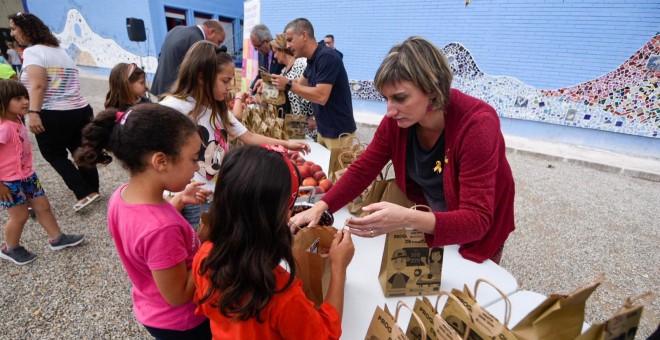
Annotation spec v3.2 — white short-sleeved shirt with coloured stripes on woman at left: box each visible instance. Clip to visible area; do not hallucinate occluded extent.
[21,45,88,111]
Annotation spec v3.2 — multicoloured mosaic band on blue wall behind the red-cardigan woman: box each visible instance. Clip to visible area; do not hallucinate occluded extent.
[351,33,660,138]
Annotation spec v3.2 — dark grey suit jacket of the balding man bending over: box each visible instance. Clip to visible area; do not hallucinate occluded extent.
[151,26,204,96]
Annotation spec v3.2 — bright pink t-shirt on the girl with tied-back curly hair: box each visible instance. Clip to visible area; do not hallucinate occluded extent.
[108,184,206,330]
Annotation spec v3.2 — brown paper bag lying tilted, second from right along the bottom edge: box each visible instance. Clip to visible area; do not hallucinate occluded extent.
[512,275,605,340]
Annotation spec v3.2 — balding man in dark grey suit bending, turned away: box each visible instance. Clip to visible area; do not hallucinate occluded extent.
[151,20,226,96]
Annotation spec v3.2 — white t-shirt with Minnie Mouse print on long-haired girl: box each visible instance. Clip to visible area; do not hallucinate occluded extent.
[159,96,248,191]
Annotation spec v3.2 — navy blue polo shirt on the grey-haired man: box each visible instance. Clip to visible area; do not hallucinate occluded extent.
[303,44,356,138]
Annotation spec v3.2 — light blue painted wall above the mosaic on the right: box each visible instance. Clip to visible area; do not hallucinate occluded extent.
[261,0,660,89]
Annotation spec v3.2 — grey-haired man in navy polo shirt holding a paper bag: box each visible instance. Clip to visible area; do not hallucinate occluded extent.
[272,18,356,149]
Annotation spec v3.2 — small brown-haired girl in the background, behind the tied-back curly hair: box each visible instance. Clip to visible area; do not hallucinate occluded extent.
[105,63,151,111]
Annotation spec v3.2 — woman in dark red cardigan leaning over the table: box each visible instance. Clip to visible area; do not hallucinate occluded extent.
[291,37,514,263]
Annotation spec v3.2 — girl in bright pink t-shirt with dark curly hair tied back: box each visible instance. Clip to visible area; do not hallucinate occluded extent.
[75,104,211,339]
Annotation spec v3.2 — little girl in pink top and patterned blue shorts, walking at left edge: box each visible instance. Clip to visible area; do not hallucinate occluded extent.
[0,79,85,265]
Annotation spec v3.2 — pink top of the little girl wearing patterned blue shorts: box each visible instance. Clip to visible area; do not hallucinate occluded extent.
[0,119,34,182]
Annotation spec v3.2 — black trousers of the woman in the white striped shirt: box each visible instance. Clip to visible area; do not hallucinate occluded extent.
[36,105,99,200]
